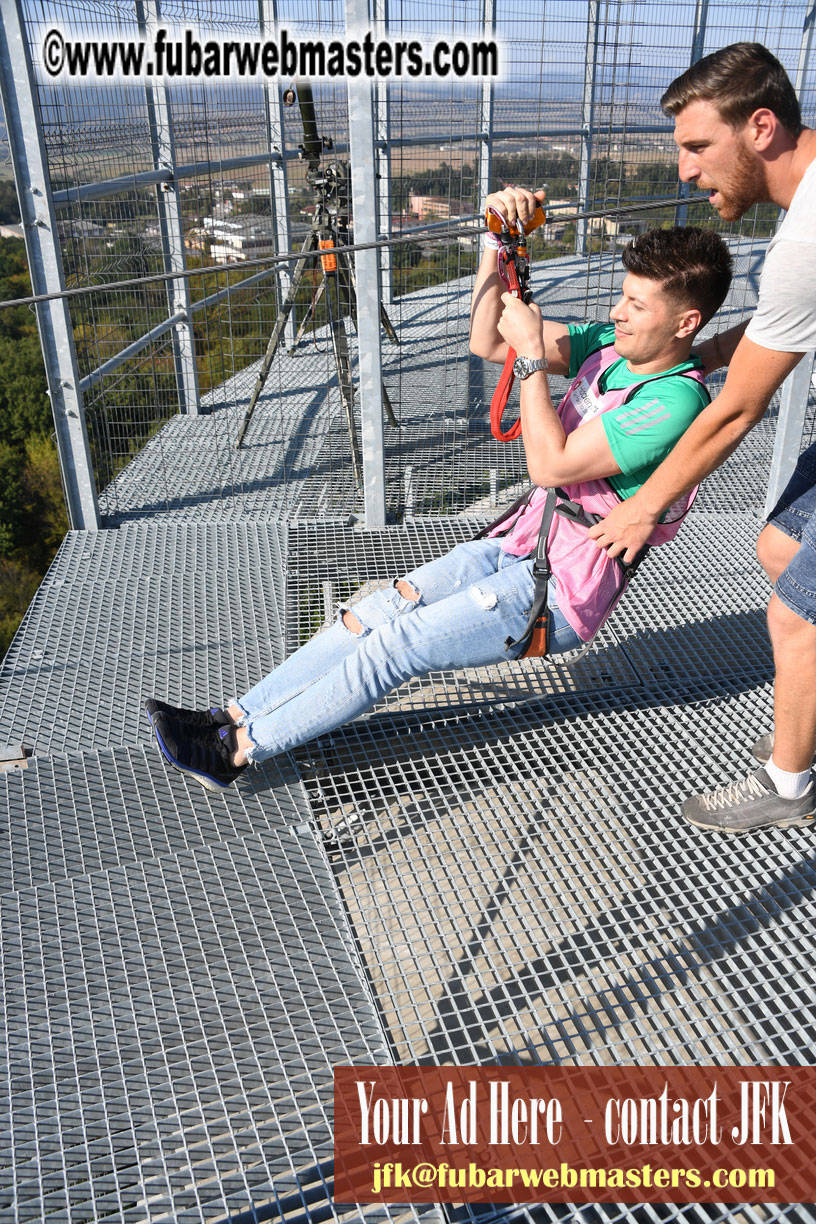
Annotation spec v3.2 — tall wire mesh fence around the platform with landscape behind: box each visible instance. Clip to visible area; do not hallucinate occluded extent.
[7,0,814,521]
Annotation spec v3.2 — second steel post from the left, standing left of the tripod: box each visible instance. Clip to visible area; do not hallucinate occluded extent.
[136,0,201,416]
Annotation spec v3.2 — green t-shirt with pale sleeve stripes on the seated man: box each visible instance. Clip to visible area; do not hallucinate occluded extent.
[568,323,710,497]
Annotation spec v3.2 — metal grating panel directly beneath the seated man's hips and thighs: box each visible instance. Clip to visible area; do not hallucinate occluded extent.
[286,514,771,712]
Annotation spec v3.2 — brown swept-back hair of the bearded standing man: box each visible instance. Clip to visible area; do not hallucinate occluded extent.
[661,43,803,136]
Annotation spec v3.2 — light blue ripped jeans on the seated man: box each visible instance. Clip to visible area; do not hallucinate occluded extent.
[237,540,582,761]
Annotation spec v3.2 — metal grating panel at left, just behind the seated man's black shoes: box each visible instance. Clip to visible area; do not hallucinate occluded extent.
[0,523,286,754]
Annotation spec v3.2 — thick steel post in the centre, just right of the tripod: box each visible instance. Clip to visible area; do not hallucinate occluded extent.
[346,0,385,528]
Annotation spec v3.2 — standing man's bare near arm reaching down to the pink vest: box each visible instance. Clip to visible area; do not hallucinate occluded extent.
[590,335,803,561]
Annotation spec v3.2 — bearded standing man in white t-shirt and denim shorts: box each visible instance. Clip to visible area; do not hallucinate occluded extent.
[591,43,816,832]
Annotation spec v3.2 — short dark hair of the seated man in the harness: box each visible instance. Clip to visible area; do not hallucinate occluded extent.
[621,225,734,327]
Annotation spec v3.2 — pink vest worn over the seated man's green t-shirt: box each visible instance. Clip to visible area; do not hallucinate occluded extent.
[476,345,703,659]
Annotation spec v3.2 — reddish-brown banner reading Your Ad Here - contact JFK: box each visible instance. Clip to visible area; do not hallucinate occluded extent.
[334,1066,816,1203]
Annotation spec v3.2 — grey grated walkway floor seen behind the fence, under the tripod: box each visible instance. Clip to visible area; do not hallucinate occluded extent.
[55,231,776,523]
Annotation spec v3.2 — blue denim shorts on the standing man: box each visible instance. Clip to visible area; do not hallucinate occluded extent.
[768,443,816,624]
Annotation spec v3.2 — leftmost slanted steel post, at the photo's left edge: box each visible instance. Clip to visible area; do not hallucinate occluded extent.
[0,0,99,531]
